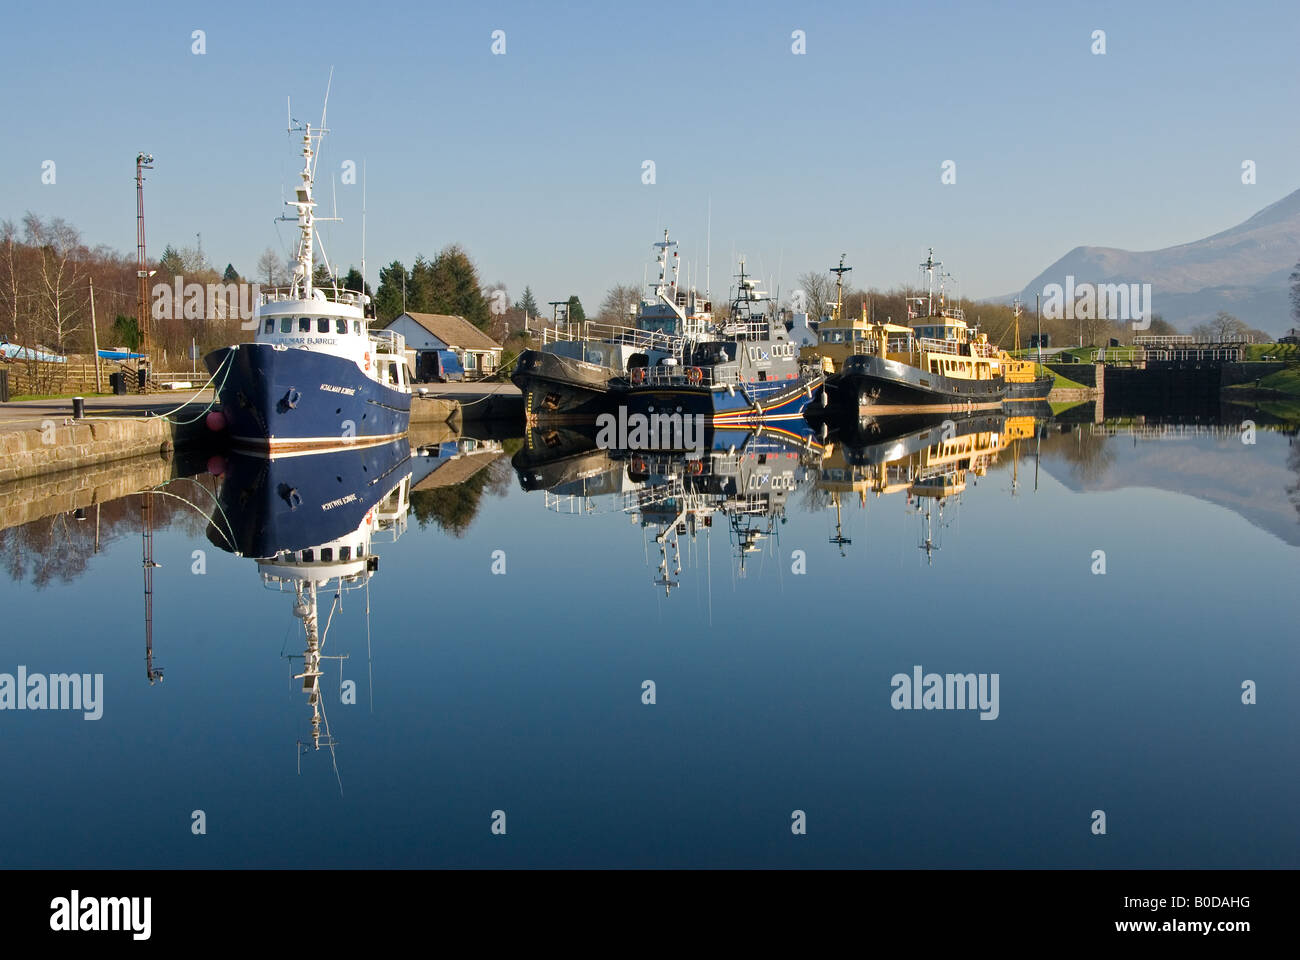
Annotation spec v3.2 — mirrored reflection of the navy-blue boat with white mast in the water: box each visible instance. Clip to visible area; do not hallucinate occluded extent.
[208,440,411,749]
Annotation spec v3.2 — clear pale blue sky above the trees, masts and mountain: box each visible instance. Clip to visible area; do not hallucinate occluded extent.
[0,3,1300,307]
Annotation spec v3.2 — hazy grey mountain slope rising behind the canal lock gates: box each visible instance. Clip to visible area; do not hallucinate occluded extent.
[1019,190,1300,333]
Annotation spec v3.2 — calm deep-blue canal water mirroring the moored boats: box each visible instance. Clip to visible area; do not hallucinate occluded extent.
[0,411,1300,866]
